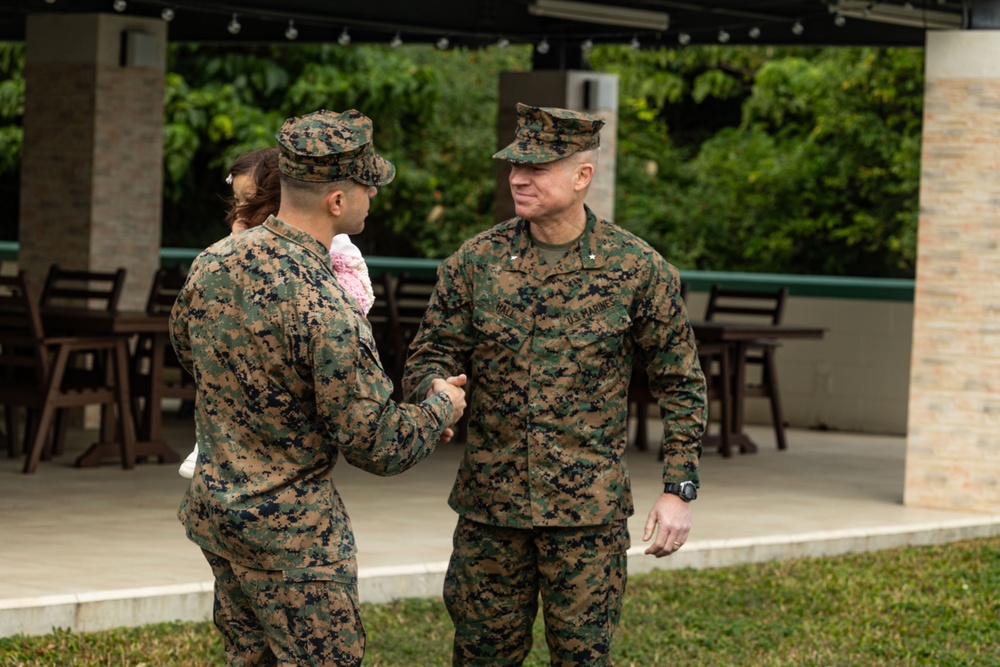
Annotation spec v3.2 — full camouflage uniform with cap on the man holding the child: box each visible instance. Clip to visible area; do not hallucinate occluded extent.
[171,112,452,665]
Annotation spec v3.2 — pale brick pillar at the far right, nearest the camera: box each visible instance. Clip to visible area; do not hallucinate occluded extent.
[904,30,1000,513]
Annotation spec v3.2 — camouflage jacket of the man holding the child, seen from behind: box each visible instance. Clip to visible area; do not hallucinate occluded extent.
[170,216,452,570]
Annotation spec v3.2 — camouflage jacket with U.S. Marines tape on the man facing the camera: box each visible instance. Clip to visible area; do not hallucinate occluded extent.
[403,209,705,528]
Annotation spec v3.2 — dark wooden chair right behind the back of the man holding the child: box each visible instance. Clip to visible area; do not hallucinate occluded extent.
[131,267,197,441]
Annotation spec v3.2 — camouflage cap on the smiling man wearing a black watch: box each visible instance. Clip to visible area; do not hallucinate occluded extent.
[493,102,604,164]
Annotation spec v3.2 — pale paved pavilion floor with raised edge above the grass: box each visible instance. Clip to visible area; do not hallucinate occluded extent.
[0,416,1000,636]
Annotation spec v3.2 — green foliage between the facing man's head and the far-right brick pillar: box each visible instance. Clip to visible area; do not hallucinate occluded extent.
[594,47,923,277]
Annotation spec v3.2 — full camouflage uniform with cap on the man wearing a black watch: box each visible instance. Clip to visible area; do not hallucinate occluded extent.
[403,105,705,665]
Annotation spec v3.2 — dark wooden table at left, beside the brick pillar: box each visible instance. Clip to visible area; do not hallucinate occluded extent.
[40,307,180,468]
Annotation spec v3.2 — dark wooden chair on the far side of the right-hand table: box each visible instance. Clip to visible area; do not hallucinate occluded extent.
[705,285,788,449]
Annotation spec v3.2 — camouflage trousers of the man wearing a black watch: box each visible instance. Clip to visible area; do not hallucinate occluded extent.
[444,518,629,667]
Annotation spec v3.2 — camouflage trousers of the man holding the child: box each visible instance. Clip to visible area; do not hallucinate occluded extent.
[202,549,366,667]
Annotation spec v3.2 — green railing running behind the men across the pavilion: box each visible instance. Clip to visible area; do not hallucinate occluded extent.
[0,241,913,301]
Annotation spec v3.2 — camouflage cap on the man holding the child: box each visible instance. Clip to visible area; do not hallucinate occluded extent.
[277,109,396,186]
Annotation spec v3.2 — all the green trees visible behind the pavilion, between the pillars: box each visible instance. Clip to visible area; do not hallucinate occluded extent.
[0,44,923,277]
